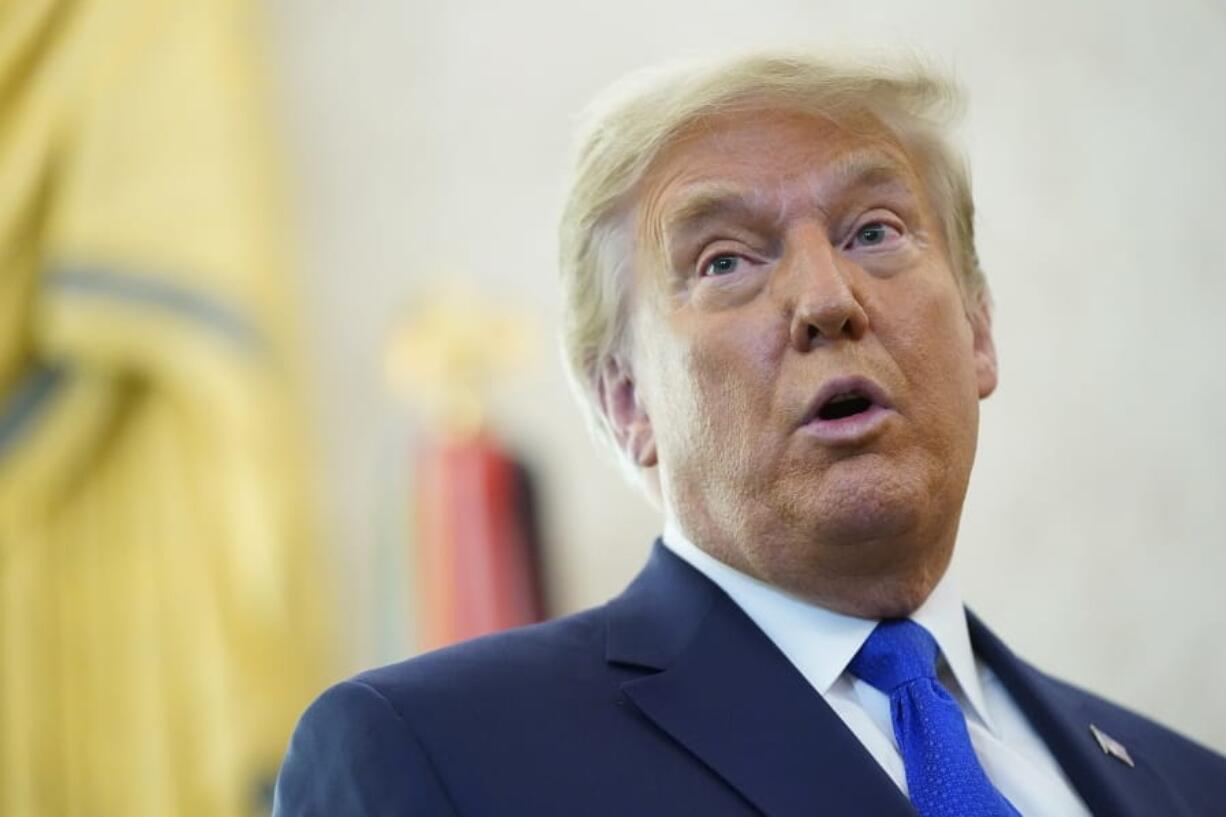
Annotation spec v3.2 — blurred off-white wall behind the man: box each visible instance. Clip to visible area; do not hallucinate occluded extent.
[272,0,1226,751]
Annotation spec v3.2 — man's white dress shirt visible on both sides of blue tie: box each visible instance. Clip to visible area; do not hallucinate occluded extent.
[663,521,1090,817]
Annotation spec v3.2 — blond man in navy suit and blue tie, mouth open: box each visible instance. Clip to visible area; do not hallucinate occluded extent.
[276,55,1226,817]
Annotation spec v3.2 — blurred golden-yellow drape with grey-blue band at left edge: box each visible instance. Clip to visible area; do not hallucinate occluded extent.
[0,0,327,817]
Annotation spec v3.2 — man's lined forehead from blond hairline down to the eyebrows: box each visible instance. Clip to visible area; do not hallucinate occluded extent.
[639,110,920,229]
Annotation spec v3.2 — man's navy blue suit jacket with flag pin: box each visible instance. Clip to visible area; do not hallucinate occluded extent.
[275,542,1226,817]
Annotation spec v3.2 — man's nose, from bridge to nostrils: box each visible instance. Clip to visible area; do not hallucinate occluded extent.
[788,229,868,352]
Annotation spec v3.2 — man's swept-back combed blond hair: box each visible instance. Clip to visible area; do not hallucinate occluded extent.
[559,53,987,472]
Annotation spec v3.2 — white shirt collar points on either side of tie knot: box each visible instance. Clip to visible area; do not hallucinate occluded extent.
[663,519,994,731]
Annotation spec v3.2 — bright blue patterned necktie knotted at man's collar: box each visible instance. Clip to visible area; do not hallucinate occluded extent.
[847,618,1019,817]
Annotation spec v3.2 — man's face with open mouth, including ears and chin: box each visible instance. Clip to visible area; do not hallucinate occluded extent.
[602,112,996,616]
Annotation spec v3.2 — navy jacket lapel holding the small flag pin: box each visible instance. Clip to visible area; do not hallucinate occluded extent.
[967,612,1182,817]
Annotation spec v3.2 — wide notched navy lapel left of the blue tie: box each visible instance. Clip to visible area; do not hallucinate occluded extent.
[608,542,915,817]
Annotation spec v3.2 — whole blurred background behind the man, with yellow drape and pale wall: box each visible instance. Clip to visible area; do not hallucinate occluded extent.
[0,0,1226,817]
